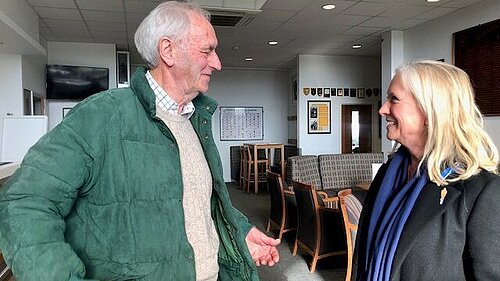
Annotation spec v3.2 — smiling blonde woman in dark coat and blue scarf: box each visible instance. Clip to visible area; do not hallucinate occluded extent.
[353,61,500,281]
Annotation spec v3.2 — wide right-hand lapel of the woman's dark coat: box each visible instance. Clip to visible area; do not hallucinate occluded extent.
[391,179,462,276]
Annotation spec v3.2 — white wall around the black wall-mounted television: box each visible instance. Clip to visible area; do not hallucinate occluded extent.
[47,41,116,130]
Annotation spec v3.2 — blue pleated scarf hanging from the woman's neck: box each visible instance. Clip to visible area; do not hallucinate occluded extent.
[361,147,429,281]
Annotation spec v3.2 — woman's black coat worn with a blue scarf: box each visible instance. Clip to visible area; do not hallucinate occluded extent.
[352,164,500,281]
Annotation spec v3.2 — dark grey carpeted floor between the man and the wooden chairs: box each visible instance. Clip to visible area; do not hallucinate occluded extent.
[227,183,345,281]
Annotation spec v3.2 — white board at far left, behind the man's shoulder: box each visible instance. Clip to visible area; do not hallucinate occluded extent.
[0,115,48,162]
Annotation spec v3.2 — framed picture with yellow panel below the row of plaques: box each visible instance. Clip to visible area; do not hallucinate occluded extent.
[307,100,332,134]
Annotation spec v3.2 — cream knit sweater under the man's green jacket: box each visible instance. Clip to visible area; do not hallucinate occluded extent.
[157,110,219,281]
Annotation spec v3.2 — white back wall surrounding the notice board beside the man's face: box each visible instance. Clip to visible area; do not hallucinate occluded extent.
[207,69,289,182]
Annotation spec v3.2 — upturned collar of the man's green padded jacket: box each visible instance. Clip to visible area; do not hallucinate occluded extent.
[130,67,217,119]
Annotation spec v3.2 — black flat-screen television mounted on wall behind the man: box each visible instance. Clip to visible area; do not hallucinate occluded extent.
[47,65,109,100]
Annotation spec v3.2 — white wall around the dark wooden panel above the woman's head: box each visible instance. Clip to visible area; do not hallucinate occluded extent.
[404,0,500,147]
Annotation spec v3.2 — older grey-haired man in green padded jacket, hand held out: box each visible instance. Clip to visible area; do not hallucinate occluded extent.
[0,1,279,280]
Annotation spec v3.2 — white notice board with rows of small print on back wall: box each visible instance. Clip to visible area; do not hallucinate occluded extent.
[220,106,264,141]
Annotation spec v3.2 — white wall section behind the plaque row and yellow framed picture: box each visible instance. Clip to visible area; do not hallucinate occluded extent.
[297,55,380,154]
